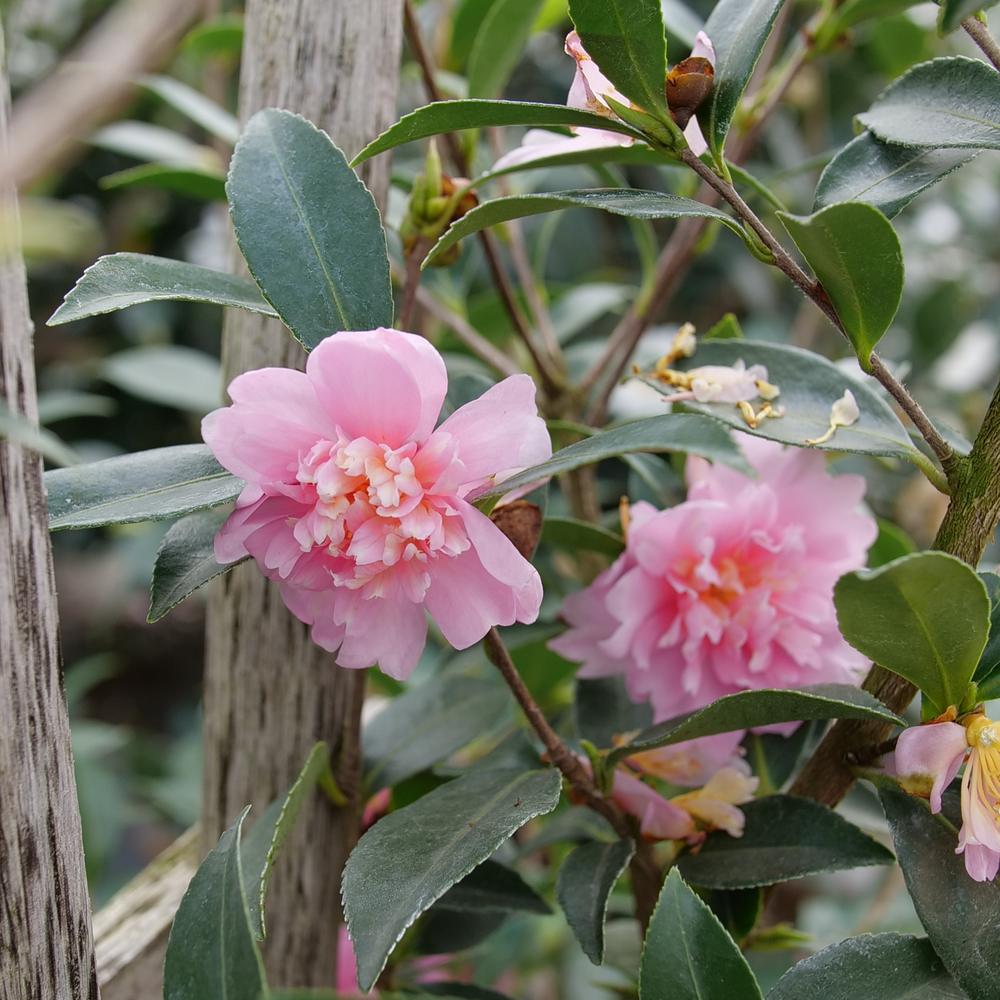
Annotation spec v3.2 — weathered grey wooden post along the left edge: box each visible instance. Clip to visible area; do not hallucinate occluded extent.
[0,21,98,1000]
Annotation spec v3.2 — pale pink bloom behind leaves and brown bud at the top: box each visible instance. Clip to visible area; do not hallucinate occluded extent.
[492,31,715,170]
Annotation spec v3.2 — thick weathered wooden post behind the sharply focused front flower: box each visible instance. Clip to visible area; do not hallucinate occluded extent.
[202,0,402,986]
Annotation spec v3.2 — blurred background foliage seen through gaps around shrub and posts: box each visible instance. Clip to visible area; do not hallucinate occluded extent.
[0,0,1000,1000]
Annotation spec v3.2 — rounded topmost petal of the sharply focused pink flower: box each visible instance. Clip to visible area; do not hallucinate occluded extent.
[306,328,448,448]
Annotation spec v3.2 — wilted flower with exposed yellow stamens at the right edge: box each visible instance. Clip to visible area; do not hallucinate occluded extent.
[896,715,1000,882]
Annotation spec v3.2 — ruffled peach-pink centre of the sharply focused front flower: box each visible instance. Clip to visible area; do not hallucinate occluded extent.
[290,428,470,601]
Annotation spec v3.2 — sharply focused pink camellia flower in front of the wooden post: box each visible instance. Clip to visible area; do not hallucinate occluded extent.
[202,328,552,679]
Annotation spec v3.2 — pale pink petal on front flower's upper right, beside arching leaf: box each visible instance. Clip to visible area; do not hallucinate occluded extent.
[428,375,552,490]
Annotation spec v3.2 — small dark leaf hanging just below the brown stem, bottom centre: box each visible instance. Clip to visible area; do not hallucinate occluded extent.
[556,839,635,965]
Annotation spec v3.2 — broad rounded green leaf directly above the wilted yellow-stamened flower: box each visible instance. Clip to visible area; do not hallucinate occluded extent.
[833,552,990,711]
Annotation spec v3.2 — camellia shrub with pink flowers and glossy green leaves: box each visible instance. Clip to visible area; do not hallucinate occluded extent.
[46,0,1000,1000]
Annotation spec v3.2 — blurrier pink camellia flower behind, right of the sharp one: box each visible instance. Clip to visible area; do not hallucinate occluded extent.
[550,436,878,722]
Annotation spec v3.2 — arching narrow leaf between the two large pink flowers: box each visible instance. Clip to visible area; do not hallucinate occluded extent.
[476,413,751,500]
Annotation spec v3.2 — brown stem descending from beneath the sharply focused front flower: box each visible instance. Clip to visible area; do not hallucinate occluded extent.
[486,628,663,936]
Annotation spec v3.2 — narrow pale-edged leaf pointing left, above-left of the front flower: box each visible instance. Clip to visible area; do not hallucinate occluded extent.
[48,253,278,326]
